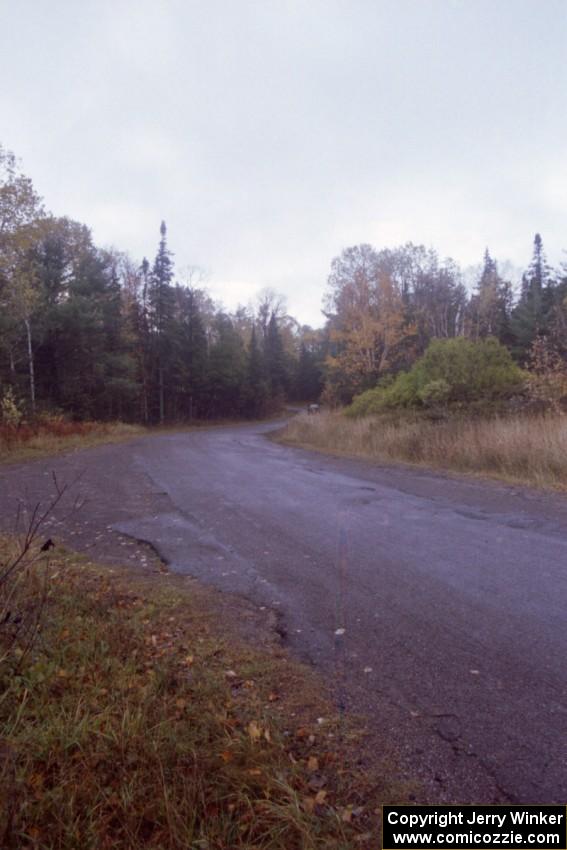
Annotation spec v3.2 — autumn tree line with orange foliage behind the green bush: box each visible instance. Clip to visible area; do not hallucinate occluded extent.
[325,234,567,403]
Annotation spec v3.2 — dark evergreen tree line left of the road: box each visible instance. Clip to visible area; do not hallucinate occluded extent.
[0,148,322,424]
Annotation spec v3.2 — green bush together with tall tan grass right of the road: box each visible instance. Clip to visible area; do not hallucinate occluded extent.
[279,339,567,489]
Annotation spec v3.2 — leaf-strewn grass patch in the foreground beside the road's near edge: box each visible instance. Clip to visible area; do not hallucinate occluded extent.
[0,538,386,850]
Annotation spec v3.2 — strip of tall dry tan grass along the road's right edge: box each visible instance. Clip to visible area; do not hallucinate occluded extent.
[281,413,567,489]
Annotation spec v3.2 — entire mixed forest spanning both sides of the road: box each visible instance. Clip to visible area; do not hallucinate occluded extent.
[0,148,567,424]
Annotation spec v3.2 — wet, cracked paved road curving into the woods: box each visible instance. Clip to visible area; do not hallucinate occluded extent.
[0,425,567,803]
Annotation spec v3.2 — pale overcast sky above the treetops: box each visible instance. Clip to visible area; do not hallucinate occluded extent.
[0,0,567,325]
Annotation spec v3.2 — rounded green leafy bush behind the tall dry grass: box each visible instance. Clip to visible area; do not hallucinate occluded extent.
[347,337,525,416]
